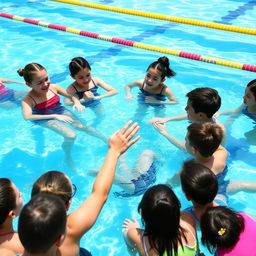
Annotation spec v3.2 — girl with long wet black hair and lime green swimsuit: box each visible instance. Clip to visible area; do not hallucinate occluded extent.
[123,184,198,256]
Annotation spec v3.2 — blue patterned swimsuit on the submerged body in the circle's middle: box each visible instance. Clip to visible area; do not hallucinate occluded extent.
[114,162,157,197]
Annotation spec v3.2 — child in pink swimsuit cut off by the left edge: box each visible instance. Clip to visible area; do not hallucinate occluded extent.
[0,77,27,108]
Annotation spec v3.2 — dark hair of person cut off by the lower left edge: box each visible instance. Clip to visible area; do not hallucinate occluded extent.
[0,178,17,227]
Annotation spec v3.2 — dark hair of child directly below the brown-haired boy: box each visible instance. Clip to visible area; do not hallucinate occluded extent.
[180,160,218,205]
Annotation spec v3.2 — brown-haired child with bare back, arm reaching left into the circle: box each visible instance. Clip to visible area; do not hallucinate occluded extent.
[154,122,256,194]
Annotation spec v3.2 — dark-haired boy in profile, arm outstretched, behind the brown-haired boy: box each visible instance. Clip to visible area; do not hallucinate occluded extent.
[149,87,226,144]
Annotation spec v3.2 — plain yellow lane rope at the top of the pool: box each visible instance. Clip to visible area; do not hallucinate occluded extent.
[50,0,256,35]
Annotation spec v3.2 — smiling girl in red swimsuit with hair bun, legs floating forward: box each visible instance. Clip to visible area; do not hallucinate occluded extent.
[18,63,106,170]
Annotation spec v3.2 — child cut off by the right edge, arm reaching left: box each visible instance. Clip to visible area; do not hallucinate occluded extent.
[215,79,256,145]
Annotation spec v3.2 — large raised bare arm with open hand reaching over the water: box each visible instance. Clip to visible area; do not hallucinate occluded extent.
[68,121,139,242]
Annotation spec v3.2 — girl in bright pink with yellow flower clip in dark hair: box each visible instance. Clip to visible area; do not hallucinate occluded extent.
[200,206,256,256]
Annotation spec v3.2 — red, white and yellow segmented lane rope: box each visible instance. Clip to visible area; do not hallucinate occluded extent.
[0,13,256,72]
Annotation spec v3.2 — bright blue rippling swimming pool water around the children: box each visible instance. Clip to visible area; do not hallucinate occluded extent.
[0,0,256,255]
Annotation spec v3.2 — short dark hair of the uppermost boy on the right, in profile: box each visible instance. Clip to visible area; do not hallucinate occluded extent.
[186,87,221,118]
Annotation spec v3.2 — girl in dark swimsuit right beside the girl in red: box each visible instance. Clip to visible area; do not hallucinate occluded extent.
[65,57,118,123]
